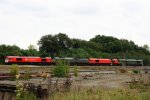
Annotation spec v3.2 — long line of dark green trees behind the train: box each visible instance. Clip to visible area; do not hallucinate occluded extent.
[0,33,150,65]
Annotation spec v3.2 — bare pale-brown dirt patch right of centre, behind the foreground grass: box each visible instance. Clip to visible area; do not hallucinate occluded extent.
[76,74,131,89]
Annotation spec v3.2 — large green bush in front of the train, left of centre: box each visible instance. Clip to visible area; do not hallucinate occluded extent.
[53,60,70,77]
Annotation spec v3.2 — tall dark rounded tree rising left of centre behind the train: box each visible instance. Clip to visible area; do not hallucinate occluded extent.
[38,33,72,57]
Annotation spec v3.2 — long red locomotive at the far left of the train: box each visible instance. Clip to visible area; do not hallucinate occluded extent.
[5,56,52,64]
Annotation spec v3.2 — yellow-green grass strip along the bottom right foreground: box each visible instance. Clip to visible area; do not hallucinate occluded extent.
[48,87,150,100]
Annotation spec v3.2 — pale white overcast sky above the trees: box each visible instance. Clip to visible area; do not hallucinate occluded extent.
[0,0,150,49]
